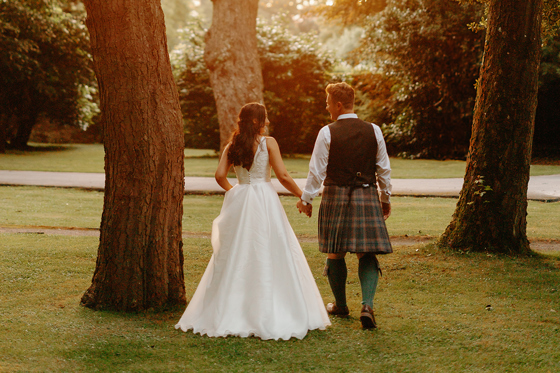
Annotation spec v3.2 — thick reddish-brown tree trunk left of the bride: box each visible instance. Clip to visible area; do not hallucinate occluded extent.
[81,0,186,311]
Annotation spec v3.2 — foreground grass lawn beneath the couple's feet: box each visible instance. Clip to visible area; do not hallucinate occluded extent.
[0,234,560,373]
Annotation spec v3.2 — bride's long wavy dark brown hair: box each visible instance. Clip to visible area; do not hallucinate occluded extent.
[228,102,266,170]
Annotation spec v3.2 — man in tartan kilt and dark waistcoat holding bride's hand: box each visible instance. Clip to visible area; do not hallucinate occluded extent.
[297,83,393,329]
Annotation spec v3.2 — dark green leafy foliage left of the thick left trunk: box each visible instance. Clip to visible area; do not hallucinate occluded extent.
[0,0,97,148]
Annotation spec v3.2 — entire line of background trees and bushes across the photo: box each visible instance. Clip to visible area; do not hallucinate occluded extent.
[0,0,560,159]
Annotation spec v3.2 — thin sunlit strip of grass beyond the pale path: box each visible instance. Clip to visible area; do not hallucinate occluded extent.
[0,144,560,179]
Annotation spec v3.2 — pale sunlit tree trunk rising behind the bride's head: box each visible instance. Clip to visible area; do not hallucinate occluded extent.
[204,0,263,151]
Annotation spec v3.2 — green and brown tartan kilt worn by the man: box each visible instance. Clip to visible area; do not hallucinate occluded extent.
[319,185,393,254]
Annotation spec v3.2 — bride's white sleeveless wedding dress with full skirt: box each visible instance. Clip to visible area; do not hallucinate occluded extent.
[175,137,330,340]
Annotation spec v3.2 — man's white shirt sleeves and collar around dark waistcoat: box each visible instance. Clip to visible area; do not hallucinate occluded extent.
[301,113,392,203]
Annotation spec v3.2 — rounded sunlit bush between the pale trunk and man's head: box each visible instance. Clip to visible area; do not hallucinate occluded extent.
[257,15,332,153]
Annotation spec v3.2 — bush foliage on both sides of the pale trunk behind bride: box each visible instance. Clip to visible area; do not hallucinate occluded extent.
[173,18,332,153]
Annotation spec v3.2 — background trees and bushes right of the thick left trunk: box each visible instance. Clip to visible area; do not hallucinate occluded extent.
[172,0,560,159]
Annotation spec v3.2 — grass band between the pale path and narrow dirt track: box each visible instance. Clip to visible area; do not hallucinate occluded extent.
[0,186,560,240]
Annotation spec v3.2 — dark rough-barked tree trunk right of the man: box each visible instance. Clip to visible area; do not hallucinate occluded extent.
[440,0,542,254]
